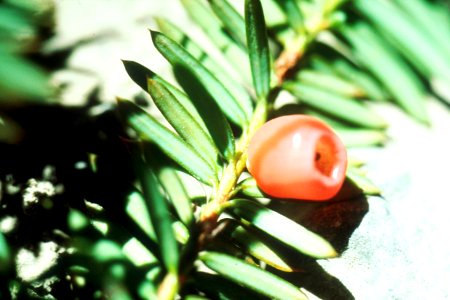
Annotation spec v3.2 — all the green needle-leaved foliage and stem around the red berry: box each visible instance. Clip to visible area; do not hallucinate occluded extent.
[0,0,450,299]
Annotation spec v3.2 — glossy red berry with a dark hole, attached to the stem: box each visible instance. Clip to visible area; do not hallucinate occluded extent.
[247,115,347,200]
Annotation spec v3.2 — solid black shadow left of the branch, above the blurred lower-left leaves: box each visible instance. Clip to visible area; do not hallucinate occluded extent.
[0,98,133,234]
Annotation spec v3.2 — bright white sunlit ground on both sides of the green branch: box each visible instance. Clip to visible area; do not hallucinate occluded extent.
[47,0,450,299]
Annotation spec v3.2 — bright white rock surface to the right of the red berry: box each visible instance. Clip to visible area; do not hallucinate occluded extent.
[320,103,450,299]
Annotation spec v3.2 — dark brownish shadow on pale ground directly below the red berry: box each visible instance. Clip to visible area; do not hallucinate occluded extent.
[270,180,369,300]
